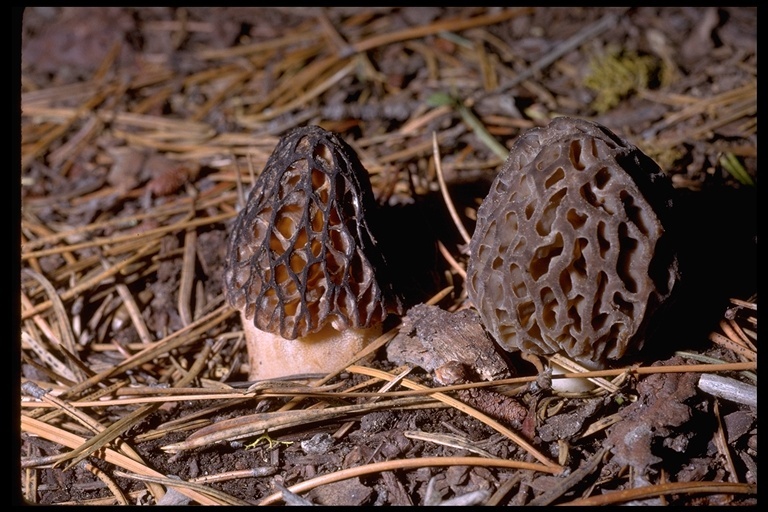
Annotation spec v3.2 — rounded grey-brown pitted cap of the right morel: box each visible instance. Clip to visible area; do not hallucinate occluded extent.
[467,117,678,368]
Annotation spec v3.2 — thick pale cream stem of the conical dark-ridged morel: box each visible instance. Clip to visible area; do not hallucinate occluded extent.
[241,313,382,380]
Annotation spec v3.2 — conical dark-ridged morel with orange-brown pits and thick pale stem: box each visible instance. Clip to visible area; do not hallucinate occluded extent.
[225,126,402,380]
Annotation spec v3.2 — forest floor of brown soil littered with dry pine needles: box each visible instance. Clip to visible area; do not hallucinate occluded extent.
[14,7,757,505]
